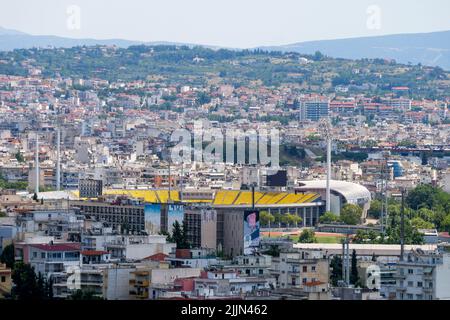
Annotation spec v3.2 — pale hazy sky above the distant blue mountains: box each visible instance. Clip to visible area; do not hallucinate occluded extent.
[0,0,450,48]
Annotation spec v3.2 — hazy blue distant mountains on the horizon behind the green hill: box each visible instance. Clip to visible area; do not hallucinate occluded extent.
[0,27,450,70]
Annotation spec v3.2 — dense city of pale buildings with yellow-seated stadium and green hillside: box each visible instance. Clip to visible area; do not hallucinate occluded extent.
[0,18,450,300]
